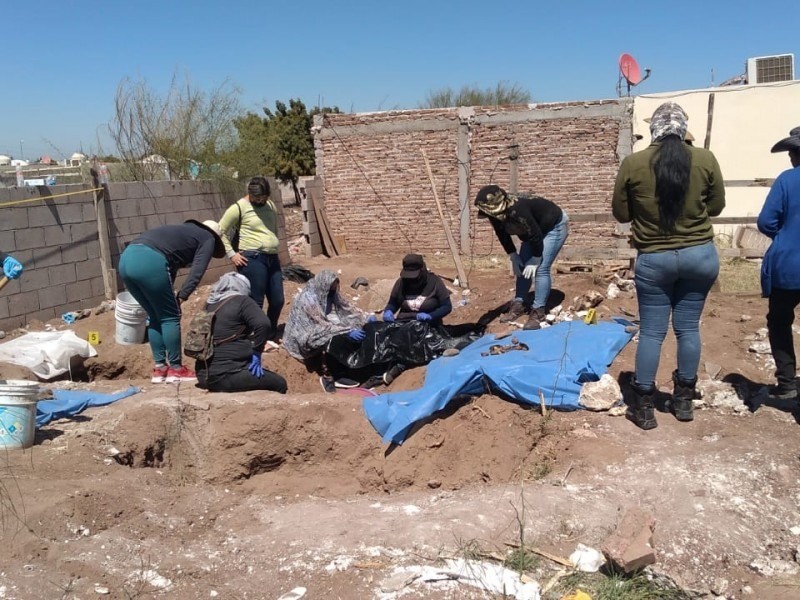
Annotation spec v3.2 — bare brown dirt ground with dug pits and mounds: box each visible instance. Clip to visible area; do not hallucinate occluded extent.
[0,240,800,600]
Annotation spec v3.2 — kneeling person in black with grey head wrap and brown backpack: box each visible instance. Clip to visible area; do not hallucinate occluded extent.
[195,273,286,394]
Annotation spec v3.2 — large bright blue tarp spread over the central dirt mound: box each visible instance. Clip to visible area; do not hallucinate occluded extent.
[363,319,632,444]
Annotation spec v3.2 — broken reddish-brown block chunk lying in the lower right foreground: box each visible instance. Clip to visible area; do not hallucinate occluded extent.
[601,507,656,573]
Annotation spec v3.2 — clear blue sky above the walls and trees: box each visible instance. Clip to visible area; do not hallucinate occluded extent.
[0,0,800,159]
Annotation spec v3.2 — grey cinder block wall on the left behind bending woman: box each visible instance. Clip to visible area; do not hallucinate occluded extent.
[0,181,289,331]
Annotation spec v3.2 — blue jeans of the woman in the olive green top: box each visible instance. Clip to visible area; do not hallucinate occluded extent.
[634,242,719,390]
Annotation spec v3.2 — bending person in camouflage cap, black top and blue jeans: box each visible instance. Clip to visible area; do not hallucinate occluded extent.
[475,185,569,329]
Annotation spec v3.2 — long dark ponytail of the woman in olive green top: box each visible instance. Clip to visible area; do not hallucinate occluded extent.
[653,135,692,233]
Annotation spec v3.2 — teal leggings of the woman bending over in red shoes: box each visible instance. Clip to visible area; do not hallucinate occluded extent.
[119,244,181,368]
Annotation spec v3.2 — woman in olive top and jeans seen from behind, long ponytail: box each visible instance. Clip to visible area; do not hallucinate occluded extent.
[611,102,725,429]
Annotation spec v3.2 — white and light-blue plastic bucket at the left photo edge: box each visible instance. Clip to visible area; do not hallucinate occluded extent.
[0,379,39,448]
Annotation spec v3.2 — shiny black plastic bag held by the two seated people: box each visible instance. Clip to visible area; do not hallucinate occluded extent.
[327,321,485,369]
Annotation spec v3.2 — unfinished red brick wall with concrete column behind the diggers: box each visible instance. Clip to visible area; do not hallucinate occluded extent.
[315,99,632,255]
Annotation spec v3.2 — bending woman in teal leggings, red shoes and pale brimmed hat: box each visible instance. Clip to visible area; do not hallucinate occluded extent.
[119,219,225,383]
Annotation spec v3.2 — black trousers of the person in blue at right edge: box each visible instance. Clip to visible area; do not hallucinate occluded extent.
[767,287,800,389]
